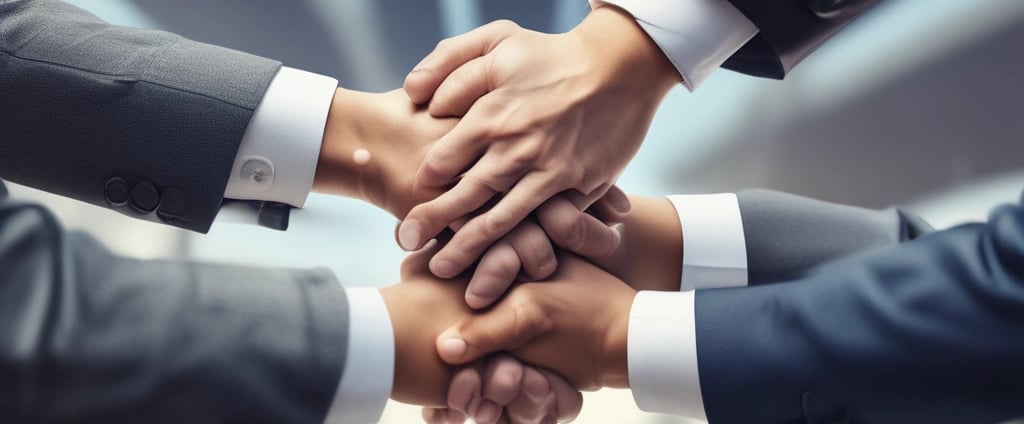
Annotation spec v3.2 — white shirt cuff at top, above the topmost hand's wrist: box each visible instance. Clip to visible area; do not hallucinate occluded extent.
[590,0,758,91]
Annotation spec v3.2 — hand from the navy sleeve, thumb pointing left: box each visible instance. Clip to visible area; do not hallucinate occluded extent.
[436,251,636,390]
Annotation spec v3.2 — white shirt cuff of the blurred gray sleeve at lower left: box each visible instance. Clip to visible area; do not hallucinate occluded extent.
[324,288,394,424]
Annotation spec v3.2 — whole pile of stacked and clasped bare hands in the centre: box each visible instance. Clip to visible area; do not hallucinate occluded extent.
[313,7,681,423]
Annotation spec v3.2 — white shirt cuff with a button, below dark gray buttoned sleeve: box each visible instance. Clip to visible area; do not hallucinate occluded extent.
[224,67,338,207]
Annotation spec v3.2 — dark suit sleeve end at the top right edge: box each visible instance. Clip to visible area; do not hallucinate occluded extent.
[723,0,879,79]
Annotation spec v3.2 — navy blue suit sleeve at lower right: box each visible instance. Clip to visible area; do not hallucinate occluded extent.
[694,193,1024,423]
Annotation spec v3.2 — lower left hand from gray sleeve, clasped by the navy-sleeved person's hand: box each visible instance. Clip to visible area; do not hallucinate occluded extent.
[380,244,583,423]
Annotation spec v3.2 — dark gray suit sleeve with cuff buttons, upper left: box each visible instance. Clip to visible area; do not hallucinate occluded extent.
[0,0,281,232]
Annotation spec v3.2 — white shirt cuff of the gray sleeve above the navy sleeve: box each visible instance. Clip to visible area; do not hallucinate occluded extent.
[668,193,746,290]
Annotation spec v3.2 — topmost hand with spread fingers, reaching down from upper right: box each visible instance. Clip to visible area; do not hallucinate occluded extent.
[398,7,679,278]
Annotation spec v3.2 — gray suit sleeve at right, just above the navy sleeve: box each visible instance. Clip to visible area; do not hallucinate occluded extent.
[737,189,932,285]
